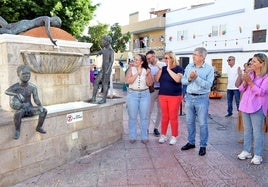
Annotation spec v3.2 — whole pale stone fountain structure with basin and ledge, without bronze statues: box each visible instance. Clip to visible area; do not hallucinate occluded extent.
[0,34,124,186]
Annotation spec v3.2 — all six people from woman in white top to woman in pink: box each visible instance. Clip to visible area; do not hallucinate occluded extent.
[126,47,268,164]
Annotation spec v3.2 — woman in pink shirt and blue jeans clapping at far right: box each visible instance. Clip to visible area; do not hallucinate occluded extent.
[238,53,268,164]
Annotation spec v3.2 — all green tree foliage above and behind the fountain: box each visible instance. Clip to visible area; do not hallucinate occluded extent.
[0,0,130,52]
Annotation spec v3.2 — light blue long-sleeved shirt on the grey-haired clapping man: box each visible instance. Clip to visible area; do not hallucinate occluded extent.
[181,63,214,94]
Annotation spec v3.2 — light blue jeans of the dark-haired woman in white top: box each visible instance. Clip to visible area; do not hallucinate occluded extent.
[127,89,151,140]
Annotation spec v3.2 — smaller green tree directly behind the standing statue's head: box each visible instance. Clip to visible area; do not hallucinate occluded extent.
[78,23,131,53]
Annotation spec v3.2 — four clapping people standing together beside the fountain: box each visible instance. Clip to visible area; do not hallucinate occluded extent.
[126,47,214,156]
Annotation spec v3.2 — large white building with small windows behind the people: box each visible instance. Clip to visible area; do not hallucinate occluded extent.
[165,0,268,76]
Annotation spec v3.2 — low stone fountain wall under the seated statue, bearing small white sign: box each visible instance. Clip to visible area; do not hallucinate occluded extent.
[0,99,124,186]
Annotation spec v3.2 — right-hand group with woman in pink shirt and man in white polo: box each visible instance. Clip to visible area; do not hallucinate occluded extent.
[226,53,268,164]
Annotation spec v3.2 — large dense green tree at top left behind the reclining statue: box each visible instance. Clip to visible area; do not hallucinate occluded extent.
[0,0,99,37]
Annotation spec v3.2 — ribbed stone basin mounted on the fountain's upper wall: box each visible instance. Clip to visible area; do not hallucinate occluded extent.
[21,50,84,74]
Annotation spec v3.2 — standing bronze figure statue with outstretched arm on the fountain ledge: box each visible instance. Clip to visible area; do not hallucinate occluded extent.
[89,35,114,104]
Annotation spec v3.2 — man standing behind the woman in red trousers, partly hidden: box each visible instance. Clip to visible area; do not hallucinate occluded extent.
[146,50,166,137]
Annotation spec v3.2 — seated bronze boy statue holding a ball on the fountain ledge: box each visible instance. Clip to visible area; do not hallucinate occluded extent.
[5,65,47,139]
